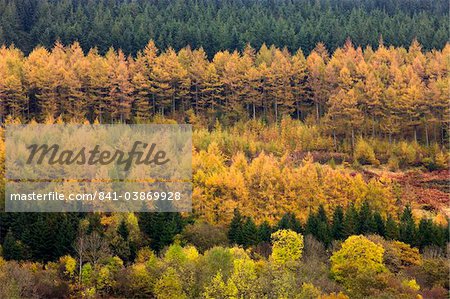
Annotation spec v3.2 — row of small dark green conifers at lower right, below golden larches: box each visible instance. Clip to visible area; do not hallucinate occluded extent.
[228,202,449,252]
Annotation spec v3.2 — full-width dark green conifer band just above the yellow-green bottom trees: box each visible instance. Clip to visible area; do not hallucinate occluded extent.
[0,191,449,263]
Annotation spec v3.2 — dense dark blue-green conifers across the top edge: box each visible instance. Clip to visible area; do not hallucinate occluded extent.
[0,0,448,57]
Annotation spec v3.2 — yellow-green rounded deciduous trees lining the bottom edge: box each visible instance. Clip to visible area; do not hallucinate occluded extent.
[0,231,448,299]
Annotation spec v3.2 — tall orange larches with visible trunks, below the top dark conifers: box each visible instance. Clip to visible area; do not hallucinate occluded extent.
[0,41,450,146]
